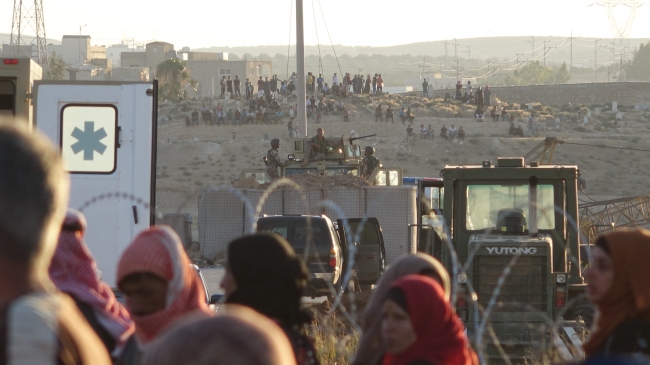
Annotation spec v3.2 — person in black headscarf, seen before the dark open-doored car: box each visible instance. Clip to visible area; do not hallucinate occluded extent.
[221,233,319,365]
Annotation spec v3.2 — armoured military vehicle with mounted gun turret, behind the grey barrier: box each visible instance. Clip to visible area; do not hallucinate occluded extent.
[241,134,402,186]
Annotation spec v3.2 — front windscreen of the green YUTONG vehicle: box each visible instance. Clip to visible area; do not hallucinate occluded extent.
[465,183,555,231]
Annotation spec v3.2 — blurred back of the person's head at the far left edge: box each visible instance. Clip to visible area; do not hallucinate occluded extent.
[0,123,68,263]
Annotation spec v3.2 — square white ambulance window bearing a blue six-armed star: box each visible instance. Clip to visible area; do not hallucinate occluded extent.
[61,105,117,174]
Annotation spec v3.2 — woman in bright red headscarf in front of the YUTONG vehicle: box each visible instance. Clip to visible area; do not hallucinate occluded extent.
[382,275,478,365]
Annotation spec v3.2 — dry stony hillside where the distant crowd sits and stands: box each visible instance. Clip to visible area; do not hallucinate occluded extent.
[156,92,650,239]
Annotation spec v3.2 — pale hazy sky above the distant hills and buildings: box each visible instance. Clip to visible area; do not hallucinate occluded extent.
[0,0,650,48]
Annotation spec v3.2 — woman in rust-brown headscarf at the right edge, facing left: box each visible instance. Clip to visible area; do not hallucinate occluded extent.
[584,229,650,357]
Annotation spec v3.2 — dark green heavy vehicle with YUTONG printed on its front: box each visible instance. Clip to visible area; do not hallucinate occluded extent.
[411,158,593,363]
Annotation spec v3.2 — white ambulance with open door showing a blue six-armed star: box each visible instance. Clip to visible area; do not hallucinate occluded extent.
[0,58,158,287]
